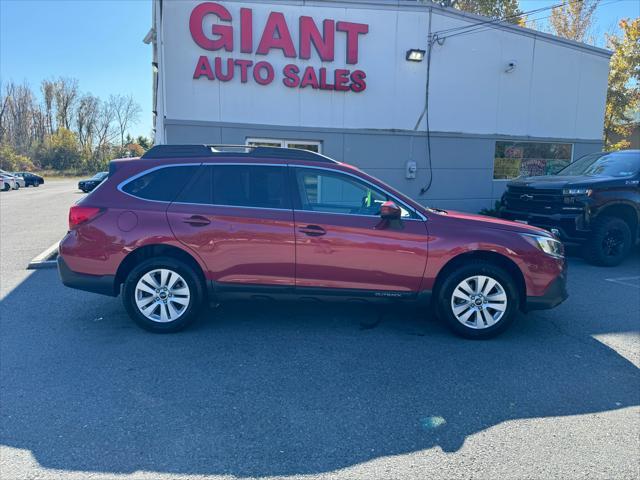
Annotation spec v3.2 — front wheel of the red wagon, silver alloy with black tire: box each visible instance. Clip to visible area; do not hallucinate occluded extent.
[436,260,520,339]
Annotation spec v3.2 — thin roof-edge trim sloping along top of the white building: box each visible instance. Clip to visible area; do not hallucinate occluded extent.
[214,0,613,58]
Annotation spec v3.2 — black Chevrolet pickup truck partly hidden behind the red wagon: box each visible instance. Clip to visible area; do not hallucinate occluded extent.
[500,150,640,266]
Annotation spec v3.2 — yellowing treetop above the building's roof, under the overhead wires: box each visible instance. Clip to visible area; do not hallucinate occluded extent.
[549,0,600,42]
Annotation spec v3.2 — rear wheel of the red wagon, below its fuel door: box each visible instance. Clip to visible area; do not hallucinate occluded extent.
[122,257,203,333]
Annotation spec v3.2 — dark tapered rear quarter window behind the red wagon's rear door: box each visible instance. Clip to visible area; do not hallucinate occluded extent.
[122,165,199,202]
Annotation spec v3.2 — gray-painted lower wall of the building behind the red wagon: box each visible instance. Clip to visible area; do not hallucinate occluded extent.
[165,120,602,212]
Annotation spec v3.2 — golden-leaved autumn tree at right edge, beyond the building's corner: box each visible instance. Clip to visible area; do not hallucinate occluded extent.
[604,18,640,150]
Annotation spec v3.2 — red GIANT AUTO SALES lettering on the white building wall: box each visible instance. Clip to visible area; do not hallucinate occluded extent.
[189,2,369,93]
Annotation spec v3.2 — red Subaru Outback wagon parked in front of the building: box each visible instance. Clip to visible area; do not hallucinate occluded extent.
[58,145,567,338]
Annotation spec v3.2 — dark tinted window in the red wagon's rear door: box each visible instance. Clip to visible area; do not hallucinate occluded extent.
[213,165,291,209]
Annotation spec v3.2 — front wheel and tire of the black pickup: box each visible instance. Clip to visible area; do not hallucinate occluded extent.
[584,217,632,267]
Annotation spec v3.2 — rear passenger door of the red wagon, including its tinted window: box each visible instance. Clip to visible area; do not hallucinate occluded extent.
[167,164,295,289]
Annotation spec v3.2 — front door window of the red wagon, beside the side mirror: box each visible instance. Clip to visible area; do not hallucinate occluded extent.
[296,168,411,218]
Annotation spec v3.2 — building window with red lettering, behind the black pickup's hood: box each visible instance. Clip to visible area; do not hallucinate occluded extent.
[493,141,573,180]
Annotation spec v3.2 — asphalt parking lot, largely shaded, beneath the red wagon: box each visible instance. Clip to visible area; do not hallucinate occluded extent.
[0,180,640,479]
